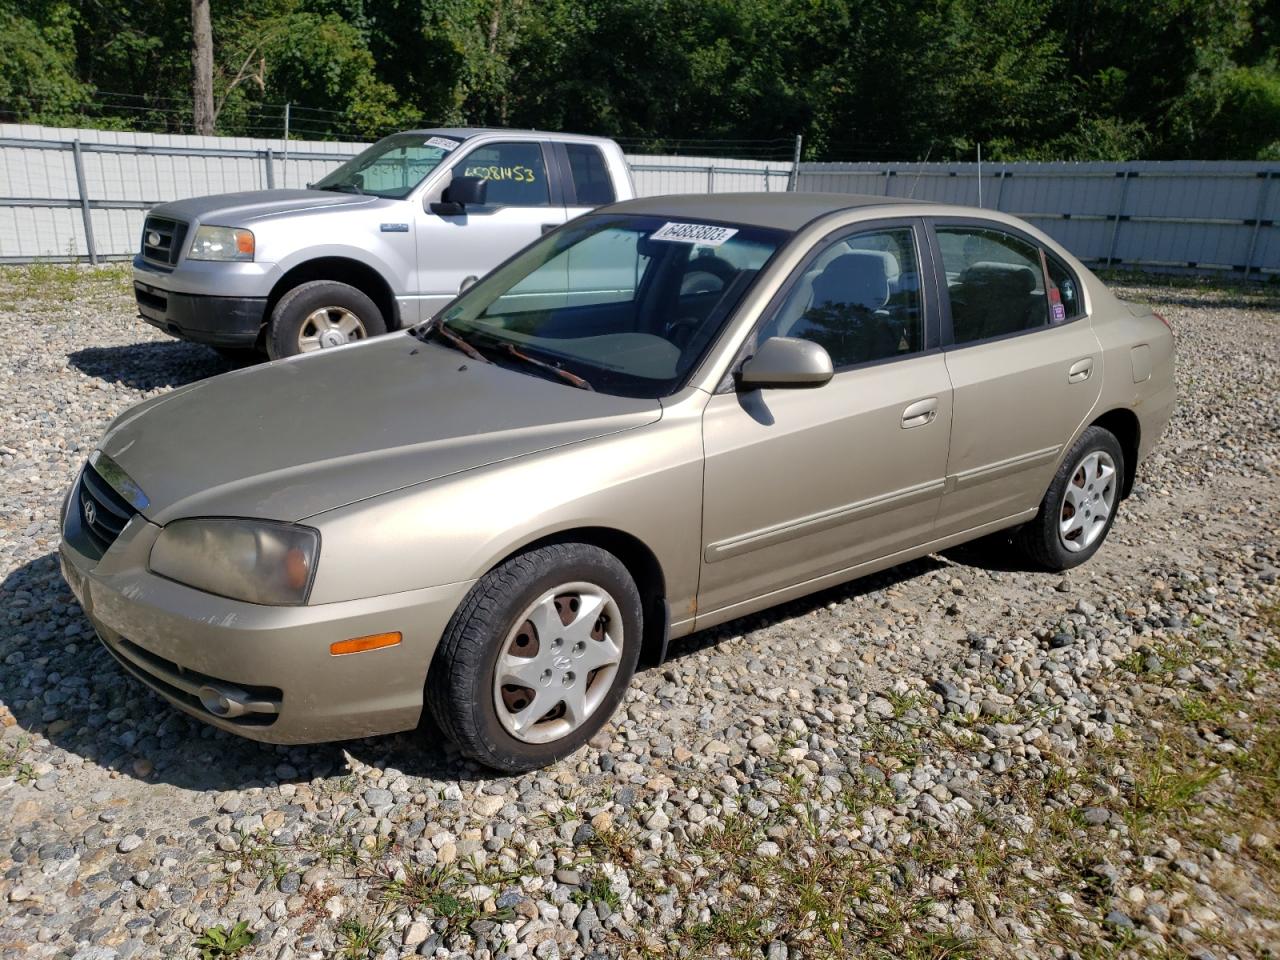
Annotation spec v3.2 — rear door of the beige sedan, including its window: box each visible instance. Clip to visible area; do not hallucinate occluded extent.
[931,218,1102,536]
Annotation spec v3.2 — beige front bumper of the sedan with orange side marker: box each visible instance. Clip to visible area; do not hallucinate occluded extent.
[59,481,471,744]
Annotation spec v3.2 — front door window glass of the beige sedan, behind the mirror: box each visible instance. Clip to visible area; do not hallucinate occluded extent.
[759,227,924,369]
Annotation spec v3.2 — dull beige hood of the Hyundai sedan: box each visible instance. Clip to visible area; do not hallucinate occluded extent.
[99,334,662,524]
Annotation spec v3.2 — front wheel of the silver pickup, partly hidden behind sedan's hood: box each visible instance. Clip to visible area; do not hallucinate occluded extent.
[266,280,387,360]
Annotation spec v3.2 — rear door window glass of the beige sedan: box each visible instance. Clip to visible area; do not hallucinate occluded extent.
[937,227,1048,343]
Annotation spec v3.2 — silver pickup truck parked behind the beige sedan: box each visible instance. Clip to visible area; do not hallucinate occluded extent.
[133,128,634,358]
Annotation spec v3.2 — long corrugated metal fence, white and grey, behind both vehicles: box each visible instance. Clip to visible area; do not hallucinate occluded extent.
[0,124,1280,278]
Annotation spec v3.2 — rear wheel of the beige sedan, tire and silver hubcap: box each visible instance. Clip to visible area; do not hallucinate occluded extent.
[1014,426,1125,571]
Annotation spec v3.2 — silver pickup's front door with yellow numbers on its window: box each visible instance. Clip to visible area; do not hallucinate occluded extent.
[416,140,564,316]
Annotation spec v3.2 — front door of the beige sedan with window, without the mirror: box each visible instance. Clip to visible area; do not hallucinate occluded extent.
[698,220,951,617]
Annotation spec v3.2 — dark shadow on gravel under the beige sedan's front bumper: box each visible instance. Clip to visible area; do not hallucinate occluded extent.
[0,553,483,791]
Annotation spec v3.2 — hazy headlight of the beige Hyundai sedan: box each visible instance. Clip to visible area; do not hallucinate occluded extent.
[147,518,320,605]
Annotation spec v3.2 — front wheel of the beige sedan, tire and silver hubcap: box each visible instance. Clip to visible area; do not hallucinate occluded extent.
[425,543,644,773]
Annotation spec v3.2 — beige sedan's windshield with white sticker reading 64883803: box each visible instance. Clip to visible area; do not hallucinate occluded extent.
[438,214,788,398]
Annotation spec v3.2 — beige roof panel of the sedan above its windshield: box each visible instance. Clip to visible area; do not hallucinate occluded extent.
[603,193,938,230]
